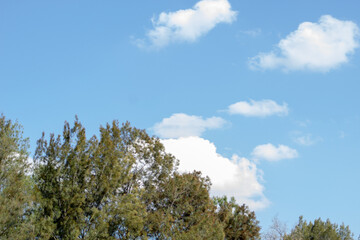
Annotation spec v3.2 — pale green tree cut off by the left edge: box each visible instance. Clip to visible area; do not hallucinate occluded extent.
[0,115,31,239]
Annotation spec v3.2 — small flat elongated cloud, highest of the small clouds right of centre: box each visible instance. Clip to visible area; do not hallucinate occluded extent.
[228,99,289,117]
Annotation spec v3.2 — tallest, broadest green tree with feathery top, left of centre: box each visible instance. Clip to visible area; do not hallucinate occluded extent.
[34,119,175,239]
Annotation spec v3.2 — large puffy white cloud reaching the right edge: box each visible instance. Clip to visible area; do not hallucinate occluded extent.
[250,15,359,72]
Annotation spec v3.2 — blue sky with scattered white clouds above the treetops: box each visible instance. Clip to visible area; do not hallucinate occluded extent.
[0,0,360,235]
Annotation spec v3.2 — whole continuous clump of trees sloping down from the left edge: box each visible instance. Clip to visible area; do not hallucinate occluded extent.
[0,116,260,240]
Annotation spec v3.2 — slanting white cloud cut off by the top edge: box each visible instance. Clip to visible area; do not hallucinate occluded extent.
[138,0,236,48]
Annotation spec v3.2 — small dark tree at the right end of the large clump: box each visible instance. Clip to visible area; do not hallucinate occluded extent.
[214,197,260,240]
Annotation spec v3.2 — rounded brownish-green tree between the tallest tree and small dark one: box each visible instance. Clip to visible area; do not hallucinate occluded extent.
[149,172,224,240]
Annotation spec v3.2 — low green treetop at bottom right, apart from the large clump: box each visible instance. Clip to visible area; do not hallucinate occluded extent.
[285,216,354,240]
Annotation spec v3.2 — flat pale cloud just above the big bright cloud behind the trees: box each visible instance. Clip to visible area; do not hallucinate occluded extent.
[152,113,226,138]
